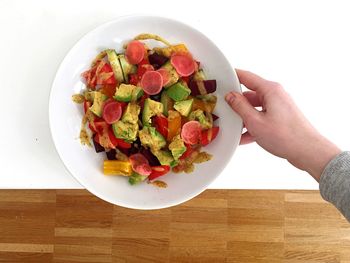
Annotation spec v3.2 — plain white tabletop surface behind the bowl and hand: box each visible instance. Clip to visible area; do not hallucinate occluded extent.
[0,0,350,189]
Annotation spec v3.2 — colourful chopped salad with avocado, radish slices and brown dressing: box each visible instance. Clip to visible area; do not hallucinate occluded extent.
[72,34,219,187]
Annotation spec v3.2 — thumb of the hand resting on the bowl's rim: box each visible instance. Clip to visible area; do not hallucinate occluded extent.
[225,92,258,123]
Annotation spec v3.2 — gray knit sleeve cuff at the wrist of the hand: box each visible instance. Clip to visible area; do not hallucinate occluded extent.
[320,152,350,222]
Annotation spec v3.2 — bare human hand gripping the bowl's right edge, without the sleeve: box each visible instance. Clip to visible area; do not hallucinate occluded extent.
[225,69,341,181]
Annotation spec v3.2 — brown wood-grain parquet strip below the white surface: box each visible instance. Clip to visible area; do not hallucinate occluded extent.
[0,190,350,263]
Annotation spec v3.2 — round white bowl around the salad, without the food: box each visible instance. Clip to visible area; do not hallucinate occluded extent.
[49,16,242,209]
